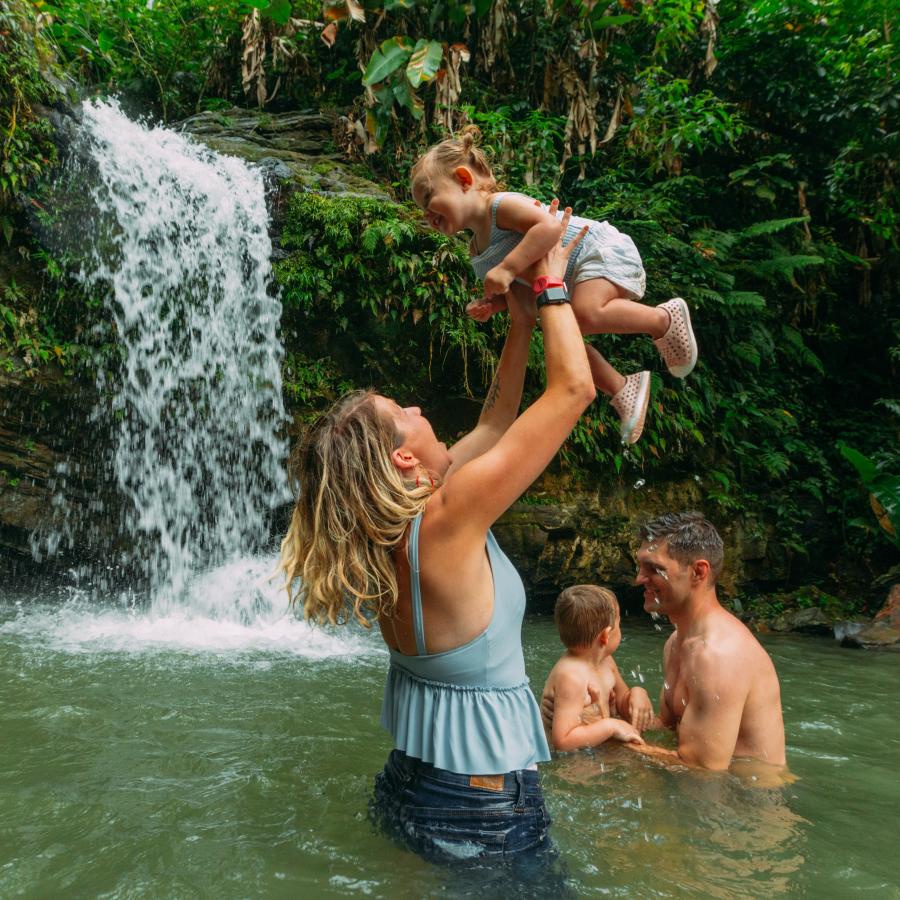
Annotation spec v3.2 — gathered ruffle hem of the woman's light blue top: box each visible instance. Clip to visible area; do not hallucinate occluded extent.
[381,664,550,775]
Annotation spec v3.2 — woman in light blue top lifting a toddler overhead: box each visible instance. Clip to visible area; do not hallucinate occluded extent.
[282,208,595,861]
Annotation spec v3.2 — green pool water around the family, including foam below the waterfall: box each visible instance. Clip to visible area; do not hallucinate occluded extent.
[0,595,900,898]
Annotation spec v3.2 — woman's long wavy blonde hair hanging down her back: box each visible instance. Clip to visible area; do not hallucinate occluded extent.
[279,391,435,627]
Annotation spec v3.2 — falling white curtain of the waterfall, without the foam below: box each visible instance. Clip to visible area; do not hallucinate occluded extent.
[47,101,289,606]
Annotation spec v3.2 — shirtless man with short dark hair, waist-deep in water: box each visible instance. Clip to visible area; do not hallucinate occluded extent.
[634,512,785,769]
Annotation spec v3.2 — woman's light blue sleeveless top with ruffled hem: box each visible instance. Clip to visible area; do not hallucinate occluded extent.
[381,513,550,775]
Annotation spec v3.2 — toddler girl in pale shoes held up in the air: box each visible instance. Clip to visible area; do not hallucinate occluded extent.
[412,126,697,444]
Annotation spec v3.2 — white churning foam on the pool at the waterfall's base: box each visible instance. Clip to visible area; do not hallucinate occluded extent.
[0,557,385,659]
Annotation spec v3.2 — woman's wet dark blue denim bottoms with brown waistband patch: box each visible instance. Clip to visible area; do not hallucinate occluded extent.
[369,750,556,868]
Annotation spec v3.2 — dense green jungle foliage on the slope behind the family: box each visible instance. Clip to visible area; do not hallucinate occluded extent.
[0,0,900,608]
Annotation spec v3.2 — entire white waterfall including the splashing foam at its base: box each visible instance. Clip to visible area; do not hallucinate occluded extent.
[14,101,383,658]
